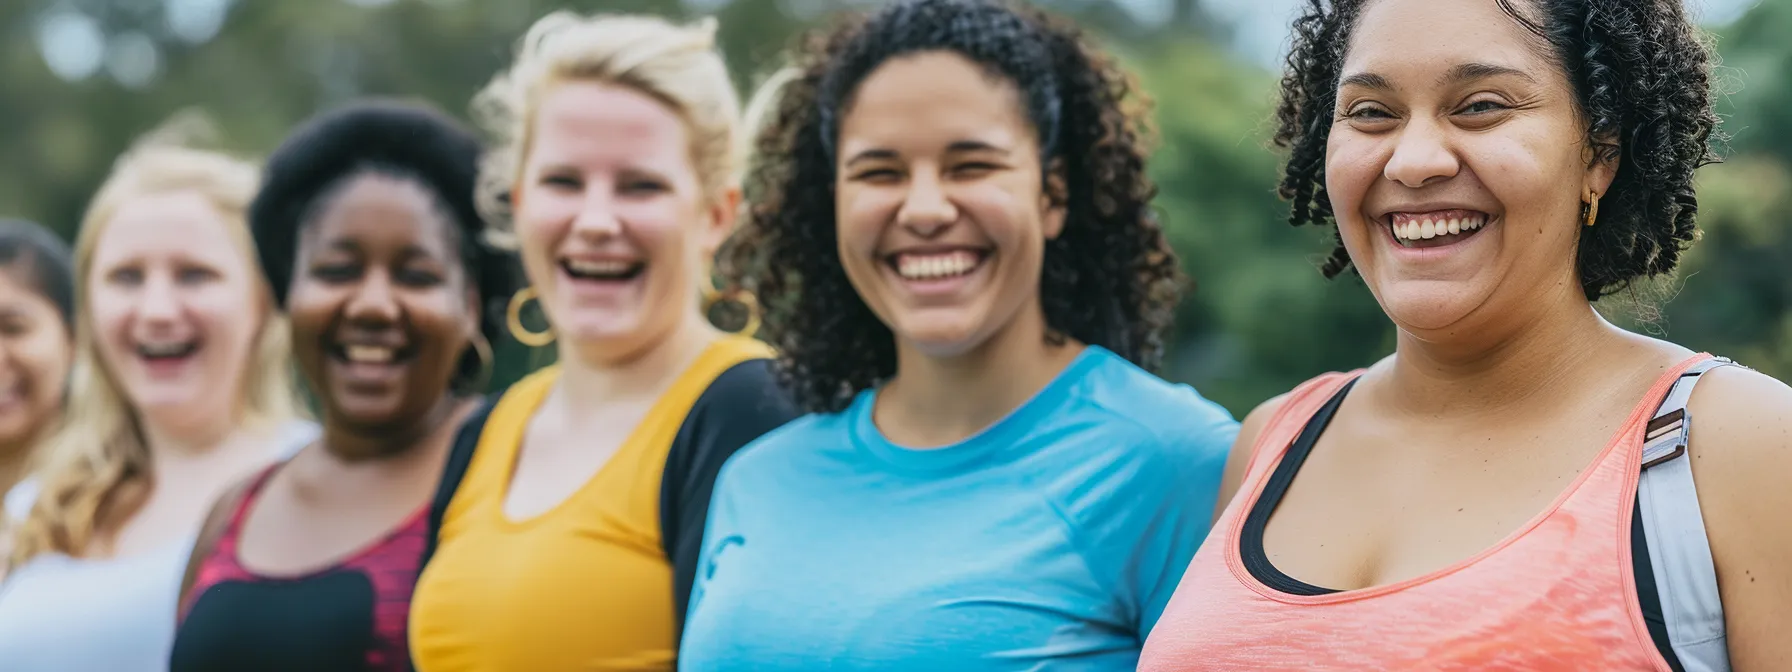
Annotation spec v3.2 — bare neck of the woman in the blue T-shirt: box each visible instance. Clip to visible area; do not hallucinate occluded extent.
[873,306,1084,448]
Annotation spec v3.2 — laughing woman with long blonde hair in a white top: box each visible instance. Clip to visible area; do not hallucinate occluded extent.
[0,123,315,672]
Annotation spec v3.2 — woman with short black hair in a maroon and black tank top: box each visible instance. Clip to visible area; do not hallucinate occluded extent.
[172,104,509,672]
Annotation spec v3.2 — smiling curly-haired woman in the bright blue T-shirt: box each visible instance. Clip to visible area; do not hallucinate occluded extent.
[681,0,1236,670]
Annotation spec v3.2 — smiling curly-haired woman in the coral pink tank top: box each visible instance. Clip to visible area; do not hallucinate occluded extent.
[1140,0,1792,672]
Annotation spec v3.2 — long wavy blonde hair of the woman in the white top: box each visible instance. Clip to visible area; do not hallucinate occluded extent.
[11,115,299,566]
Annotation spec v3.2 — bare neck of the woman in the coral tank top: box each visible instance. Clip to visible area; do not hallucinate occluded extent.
[1387,283,1645,414]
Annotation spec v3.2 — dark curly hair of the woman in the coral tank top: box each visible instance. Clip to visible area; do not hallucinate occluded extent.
[1274,0,1719,301]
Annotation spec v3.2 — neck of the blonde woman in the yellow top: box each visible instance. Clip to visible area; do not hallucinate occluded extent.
[543,315,720,418]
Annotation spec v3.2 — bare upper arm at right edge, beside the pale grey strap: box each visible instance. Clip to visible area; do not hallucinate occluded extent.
[1688,367,1792,672]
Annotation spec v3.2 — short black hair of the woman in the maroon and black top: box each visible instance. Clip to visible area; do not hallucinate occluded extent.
[249,100,516,387]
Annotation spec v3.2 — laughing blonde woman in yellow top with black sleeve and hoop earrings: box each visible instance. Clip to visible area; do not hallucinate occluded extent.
[410,13,796,672]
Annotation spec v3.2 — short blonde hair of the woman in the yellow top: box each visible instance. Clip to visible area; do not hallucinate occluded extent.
[473,11,744,247]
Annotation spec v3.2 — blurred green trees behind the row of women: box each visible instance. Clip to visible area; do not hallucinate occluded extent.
[0,0,1792,416]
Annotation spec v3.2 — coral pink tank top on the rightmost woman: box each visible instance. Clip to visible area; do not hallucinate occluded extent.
[1140,355,1710,672]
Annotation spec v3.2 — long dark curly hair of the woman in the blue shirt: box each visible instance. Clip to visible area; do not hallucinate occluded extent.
[717,0,1183,412]
